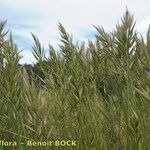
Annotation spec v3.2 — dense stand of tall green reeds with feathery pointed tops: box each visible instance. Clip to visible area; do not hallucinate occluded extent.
[0,11,150,150]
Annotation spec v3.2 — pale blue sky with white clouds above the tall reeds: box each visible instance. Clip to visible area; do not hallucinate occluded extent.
[0,0,150,64]
